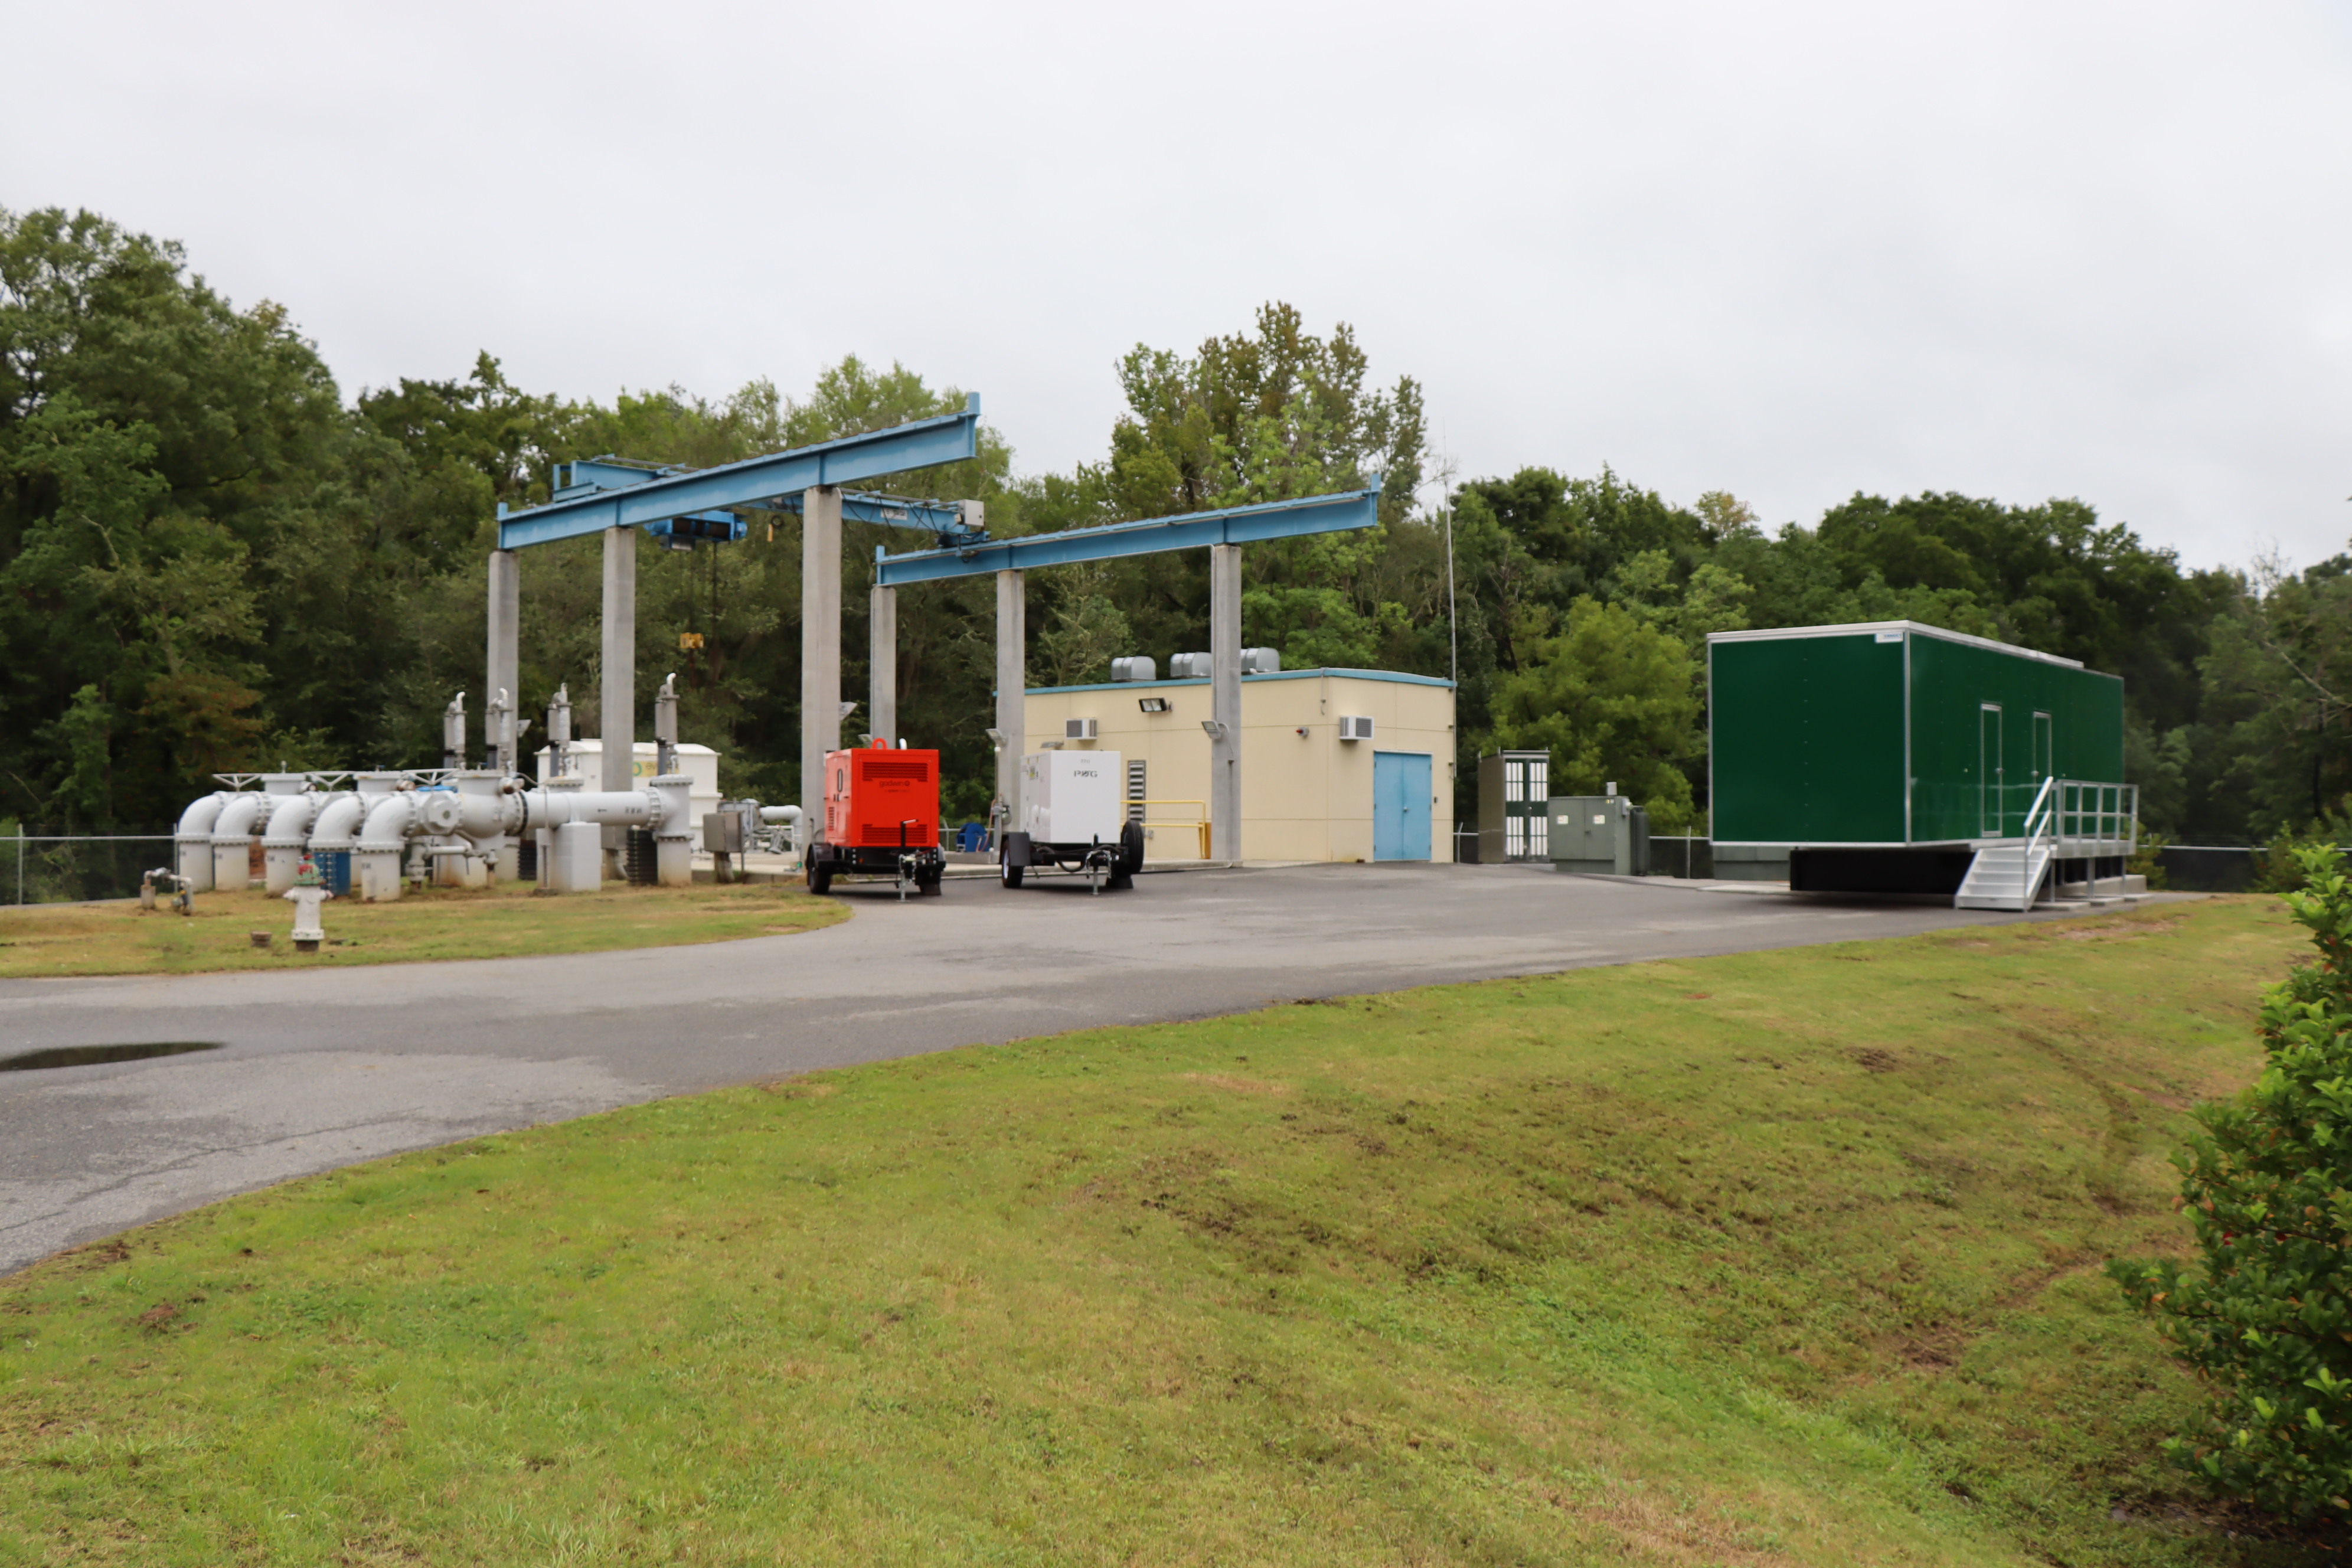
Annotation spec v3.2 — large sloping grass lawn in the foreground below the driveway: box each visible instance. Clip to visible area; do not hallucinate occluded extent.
[0,898,2298,1566]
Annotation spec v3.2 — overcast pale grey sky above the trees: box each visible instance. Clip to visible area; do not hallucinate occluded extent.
[0,0,2352,564]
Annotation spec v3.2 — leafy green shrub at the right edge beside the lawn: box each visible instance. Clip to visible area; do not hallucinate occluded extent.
[2108,851,2352,1521]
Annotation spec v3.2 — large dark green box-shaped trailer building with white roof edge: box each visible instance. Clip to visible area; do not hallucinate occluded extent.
[1707,620,2124,851]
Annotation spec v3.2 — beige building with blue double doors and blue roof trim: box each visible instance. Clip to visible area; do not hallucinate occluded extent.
[1021,670,1453,860]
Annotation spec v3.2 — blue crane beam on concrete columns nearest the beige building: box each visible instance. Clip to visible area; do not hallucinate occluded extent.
[873,475,1381,863]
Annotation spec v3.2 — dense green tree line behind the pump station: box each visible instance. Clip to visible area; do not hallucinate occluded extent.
[0,209,2352,842]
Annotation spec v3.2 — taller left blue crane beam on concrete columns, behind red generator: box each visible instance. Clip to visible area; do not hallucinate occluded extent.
[489,393,985,855]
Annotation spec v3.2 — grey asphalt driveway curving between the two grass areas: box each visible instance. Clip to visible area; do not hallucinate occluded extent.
[0,865,2154,1272]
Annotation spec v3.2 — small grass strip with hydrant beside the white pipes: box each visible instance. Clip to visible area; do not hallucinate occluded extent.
[0,881,849,980]
